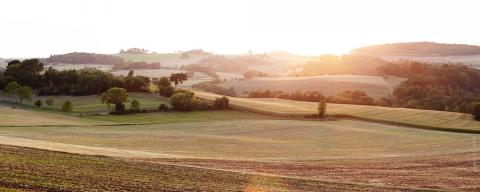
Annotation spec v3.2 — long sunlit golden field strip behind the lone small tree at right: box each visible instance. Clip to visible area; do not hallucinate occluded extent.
[196,91,480,133]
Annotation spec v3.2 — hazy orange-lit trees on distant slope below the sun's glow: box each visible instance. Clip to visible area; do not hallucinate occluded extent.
[290,54,387,76]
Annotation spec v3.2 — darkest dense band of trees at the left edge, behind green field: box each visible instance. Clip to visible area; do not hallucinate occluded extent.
[0,59,150,95]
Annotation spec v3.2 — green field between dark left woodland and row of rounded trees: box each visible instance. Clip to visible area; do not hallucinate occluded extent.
[13,93,168,114]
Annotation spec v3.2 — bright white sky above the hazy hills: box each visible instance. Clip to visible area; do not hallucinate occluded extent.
[0,0,480,58]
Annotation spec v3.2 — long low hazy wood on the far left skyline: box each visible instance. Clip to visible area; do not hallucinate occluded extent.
[45,52,125,65]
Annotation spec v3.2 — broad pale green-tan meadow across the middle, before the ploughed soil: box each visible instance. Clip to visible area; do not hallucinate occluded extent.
[0,118,474,162]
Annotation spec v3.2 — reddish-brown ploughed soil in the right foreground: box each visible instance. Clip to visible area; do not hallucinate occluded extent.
[148,153,480,191]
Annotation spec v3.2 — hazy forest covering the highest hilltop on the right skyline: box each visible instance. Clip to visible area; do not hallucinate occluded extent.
[352,42,480,56]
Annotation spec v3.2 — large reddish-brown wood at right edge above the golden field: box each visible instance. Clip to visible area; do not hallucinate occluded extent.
[379,61,480,113]
